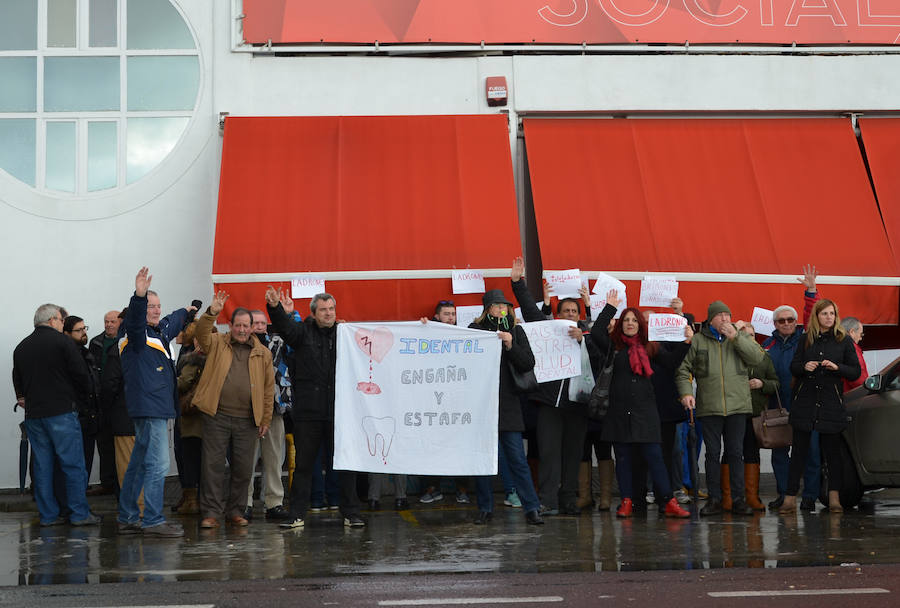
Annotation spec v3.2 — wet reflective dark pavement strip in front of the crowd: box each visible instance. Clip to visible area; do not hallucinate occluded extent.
[0,491,900,585]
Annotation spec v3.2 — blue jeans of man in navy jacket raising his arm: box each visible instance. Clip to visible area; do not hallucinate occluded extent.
[119,418,169,528]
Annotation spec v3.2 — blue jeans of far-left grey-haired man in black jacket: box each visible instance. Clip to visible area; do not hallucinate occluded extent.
[25,412,91,524]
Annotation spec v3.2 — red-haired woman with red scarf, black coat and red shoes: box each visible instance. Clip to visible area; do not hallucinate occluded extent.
[591,290,692,517]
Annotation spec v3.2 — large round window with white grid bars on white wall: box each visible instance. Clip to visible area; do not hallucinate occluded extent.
[0,0,200,198]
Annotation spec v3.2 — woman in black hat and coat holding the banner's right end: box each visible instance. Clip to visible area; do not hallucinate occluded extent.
[469,289,544,525]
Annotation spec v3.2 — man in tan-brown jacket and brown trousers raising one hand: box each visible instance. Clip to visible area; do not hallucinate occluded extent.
[192,291,275,528]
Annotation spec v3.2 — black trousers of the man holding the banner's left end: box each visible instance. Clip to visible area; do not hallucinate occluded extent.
[288,420,359,519]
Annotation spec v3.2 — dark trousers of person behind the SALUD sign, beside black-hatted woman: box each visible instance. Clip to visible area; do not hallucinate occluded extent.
[537,405,587,509]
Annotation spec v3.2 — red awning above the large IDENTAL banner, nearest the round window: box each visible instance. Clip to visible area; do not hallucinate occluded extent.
[213,115,521,320]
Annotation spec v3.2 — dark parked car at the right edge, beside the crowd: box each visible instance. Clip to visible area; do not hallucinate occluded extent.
[821,357,900,508]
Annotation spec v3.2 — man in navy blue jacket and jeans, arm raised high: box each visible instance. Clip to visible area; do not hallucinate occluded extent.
[118,266,194,537]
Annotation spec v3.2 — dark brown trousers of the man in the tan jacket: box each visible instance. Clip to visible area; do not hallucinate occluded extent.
[200,414,259,517]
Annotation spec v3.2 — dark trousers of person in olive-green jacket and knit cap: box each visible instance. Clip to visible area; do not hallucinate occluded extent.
[700,414,747,501]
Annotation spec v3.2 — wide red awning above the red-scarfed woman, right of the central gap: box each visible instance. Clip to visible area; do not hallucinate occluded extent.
[525,119,898,323]
